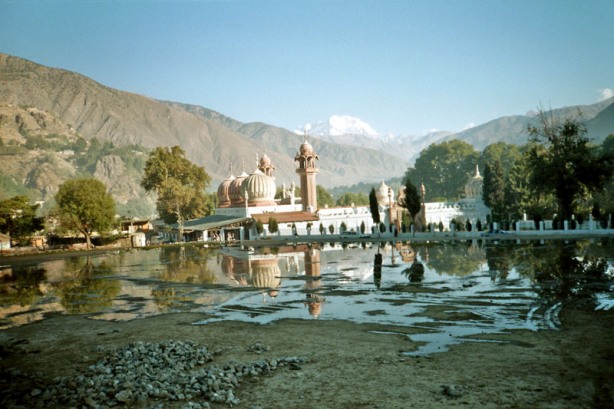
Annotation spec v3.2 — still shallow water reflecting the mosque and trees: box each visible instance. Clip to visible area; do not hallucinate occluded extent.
[0,239,614,354]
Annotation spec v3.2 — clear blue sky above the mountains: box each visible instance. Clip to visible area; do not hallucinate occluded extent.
[0,0,614,135]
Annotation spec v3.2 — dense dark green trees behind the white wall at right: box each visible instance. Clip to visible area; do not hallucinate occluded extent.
[402,111,614,223]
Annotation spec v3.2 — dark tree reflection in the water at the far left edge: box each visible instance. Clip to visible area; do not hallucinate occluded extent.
[0,266,45,307]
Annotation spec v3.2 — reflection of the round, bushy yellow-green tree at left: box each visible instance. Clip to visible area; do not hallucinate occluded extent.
[58,256,121,314]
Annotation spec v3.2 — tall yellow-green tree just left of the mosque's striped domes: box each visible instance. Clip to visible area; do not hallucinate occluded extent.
[141,146,213,240]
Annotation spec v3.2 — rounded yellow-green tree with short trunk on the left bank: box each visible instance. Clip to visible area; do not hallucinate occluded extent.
[55,178,115,248]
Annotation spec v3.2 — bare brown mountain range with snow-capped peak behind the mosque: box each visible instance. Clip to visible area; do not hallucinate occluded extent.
[0,54,614,214]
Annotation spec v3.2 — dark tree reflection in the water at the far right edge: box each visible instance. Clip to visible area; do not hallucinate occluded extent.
[534,246,611,308]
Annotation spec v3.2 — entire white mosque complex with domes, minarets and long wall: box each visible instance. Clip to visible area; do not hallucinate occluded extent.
[160,135,490,241]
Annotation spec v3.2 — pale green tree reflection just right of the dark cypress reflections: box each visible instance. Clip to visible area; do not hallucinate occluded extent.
[427,243,484,276]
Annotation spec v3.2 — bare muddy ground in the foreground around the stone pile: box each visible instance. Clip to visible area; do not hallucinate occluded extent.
[0,309,614,409]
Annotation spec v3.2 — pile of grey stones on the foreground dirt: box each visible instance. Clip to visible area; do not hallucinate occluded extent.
[22,341,309,409]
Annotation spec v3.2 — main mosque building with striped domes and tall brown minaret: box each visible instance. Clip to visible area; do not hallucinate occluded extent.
[173,136,390,241]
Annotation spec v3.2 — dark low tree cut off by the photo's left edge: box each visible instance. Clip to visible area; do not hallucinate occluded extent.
[0,196,44,242]
